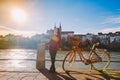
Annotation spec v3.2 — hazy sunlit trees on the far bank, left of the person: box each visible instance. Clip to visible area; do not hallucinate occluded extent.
[0,34,48,49]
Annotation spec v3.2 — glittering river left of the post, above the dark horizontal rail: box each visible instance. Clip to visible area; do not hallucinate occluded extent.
[0,49,36,59]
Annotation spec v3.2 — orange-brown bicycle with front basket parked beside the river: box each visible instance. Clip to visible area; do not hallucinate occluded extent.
[62,37,110,71]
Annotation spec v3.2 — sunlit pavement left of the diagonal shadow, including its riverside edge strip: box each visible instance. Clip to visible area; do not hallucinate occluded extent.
[0,68,48,80]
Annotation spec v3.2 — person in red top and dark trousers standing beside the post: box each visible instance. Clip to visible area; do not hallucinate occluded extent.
[46,28,61,72]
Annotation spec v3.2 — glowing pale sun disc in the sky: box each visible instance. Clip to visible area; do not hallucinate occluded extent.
[11,8,27,23]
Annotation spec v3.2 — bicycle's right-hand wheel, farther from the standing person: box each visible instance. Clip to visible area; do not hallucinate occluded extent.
[91,50,110,70]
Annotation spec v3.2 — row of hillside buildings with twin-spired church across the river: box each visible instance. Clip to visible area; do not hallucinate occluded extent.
[50,24,120,45]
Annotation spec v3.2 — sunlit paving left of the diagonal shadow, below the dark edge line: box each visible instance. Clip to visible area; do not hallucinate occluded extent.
[0,72,47,80]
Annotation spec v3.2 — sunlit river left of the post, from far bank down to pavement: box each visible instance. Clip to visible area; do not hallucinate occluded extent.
[0,49,36,67]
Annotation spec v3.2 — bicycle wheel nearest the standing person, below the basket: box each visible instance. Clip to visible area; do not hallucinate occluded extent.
[62,50,76,71]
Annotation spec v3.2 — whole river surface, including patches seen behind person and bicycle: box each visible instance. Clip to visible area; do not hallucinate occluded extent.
[0,49,120,70]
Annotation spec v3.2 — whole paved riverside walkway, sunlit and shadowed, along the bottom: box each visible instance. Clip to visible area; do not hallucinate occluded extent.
[0,68,120,80]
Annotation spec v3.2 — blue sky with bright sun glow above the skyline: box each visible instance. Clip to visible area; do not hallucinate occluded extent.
[0,0,120,36]
